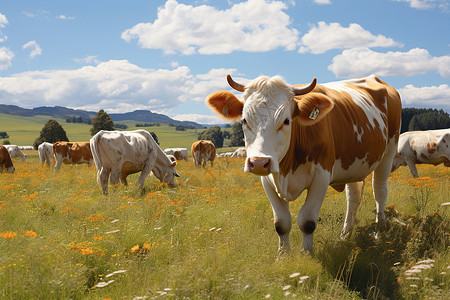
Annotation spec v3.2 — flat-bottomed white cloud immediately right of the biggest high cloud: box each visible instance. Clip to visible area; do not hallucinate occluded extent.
[299,21,402,54]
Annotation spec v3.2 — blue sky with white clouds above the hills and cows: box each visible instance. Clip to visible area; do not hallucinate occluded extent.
[0,0,450,124]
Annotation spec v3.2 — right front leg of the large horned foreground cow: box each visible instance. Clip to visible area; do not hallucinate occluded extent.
[298,180,329,253]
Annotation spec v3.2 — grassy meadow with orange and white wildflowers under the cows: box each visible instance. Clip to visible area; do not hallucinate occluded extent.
[0,151,450,299]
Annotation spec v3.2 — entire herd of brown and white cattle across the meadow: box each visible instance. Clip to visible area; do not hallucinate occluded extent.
[0,75,450,254]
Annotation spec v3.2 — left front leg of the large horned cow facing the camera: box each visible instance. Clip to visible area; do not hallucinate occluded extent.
[261,176,292,257]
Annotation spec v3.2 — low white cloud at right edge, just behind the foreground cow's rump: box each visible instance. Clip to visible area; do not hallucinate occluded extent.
[398,84,450,111]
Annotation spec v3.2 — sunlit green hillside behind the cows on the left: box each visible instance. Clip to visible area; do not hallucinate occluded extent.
[0,114,202,149]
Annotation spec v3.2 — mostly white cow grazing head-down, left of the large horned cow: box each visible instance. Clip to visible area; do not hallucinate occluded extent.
[90,130,180,195]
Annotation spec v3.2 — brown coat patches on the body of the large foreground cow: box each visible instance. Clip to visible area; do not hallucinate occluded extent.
[280,79,401,175]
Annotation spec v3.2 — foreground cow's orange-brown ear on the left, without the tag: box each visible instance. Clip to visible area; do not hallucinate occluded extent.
[206,91,244,121]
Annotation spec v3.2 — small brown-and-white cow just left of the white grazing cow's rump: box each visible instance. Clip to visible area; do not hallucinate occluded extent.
[53,142,93,172]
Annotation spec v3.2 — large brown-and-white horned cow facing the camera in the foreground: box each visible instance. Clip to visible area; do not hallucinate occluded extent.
[206,75,401,254]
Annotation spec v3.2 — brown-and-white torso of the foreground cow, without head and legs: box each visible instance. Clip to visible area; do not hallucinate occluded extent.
[280,76,401,182]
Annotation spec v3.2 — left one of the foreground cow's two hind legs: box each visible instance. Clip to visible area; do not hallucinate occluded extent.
[341,181,364,239]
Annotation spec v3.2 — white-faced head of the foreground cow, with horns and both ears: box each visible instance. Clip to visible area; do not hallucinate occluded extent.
[206,75,334,176]
